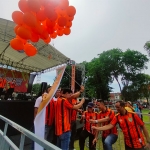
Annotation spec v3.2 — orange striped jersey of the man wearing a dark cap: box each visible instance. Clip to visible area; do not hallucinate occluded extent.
[83,111,98,134]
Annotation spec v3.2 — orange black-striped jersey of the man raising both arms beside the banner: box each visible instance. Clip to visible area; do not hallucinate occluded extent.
[55,97,73,136]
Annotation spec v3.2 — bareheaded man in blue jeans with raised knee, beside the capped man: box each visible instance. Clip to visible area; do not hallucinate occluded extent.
[90,100,118,150]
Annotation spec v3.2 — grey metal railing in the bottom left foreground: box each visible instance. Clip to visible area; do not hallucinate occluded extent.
[0,115,61,150]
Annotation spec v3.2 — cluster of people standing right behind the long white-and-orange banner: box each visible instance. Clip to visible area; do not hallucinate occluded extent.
[34,86,85,150]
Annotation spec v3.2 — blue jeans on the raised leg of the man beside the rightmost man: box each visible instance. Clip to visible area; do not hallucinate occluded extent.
[102,134,118,150]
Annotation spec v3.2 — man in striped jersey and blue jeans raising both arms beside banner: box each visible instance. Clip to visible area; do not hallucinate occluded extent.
[55,86,85,150]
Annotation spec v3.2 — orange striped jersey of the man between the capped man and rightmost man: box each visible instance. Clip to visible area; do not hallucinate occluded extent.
[98,108,117,138]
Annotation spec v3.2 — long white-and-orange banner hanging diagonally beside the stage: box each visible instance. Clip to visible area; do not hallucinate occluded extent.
[34,66,66,150]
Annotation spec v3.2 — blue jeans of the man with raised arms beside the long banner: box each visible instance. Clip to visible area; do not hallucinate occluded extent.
[57,131,71,150]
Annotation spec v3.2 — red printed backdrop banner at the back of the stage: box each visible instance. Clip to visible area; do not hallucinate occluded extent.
[0,68,30,93]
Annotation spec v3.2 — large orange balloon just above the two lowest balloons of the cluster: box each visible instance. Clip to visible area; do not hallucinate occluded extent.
[17,26,31,40]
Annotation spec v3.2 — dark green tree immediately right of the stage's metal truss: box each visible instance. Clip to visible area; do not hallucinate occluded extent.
[86,58,110,99]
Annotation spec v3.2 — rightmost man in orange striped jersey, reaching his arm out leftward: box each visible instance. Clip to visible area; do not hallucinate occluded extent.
[92,101,150,150]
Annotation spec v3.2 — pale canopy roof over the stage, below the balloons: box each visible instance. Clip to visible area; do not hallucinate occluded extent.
[0,18,69,73]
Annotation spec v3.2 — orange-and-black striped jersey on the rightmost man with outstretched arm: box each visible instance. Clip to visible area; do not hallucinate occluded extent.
[111,111,145,148]
